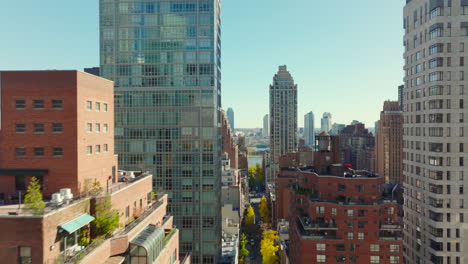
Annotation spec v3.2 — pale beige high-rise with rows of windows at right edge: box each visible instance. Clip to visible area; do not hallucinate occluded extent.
[403,0,468,264]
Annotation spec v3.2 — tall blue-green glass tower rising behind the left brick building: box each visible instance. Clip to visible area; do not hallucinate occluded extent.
[100,0,221,263]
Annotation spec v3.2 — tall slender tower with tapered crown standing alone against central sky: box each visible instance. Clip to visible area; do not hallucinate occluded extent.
[267,65,297,183]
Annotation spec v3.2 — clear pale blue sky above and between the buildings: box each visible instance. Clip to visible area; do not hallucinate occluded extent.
[0,0,404,128]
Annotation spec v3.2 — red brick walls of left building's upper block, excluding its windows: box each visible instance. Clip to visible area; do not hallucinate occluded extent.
[0,71,117,196]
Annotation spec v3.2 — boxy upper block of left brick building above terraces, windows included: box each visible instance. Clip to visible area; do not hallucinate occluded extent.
[0,71,117,200]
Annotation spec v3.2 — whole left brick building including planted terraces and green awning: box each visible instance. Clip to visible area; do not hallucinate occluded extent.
[0,71,186,264]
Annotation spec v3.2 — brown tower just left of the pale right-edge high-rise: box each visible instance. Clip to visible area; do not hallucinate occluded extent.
[375,101,403,184]
